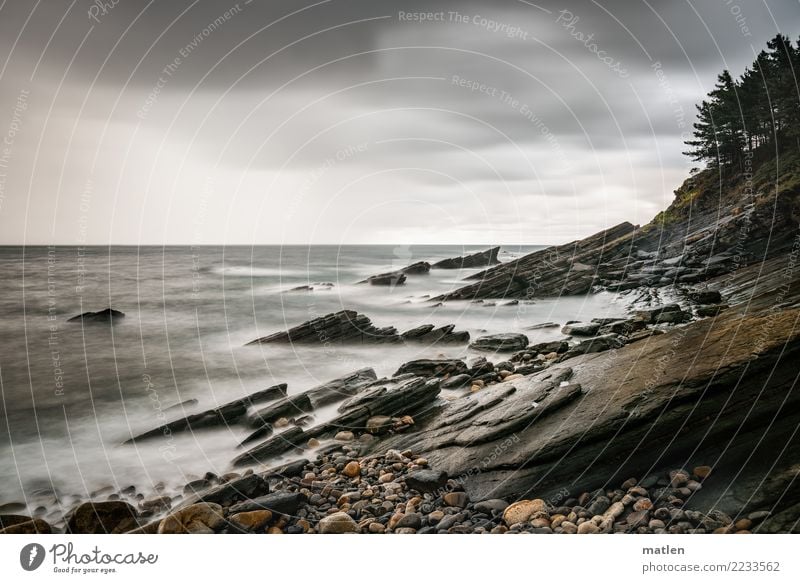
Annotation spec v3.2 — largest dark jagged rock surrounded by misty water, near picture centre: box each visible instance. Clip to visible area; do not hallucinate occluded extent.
[248,310,400,345]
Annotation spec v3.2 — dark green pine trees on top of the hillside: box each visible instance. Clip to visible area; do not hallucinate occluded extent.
[685,34,800,169]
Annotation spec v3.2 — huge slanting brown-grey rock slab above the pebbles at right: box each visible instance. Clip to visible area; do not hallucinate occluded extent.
[381,300,800,513]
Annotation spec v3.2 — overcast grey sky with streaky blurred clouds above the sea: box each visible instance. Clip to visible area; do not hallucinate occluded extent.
[0,0,800,245]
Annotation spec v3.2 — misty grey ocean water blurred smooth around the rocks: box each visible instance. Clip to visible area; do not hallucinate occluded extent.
[0,245,624,507]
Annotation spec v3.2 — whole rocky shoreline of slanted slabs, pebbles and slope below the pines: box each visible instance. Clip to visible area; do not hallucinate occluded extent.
[0,155,800,534]
